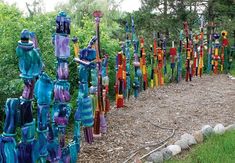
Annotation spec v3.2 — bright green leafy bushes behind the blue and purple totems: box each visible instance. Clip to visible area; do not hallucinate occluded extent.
[0,1,120,119]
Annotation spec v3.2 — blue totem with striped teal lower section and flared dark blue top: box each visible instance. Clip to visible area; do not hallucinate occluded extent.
[74,37,98,145]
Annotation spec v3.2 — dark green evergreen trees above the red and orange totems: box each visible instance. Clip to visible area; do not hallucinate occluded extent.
[132,0,235,46]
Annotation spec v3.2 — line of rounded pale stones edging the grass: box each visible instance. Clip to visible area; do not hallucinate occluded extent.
[145,123,235,163]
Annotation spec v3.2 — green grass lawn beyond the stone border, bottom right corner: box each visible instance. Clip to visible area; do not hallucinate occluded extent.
[167,131,235,163]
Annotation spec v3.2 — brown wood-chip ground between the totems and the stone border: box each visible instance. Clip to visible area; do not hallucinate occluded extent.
[79,75,235,163]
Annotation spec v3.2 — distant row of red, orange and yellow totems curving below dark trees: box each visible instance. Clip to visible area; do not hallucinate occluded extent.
[115,17,235,108]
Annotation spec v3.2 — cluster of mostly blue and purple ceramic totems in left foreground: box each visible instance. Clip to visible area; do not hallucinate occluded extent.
[0,12,109,163]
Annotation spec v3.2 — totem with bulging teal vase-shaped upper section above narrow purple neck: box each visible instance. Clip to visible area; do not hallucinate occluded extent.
[16,30,42,162]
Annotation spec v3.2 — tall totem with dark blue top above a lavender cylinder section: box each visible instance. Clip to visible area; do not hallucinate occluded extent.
[49,12,71,161]
